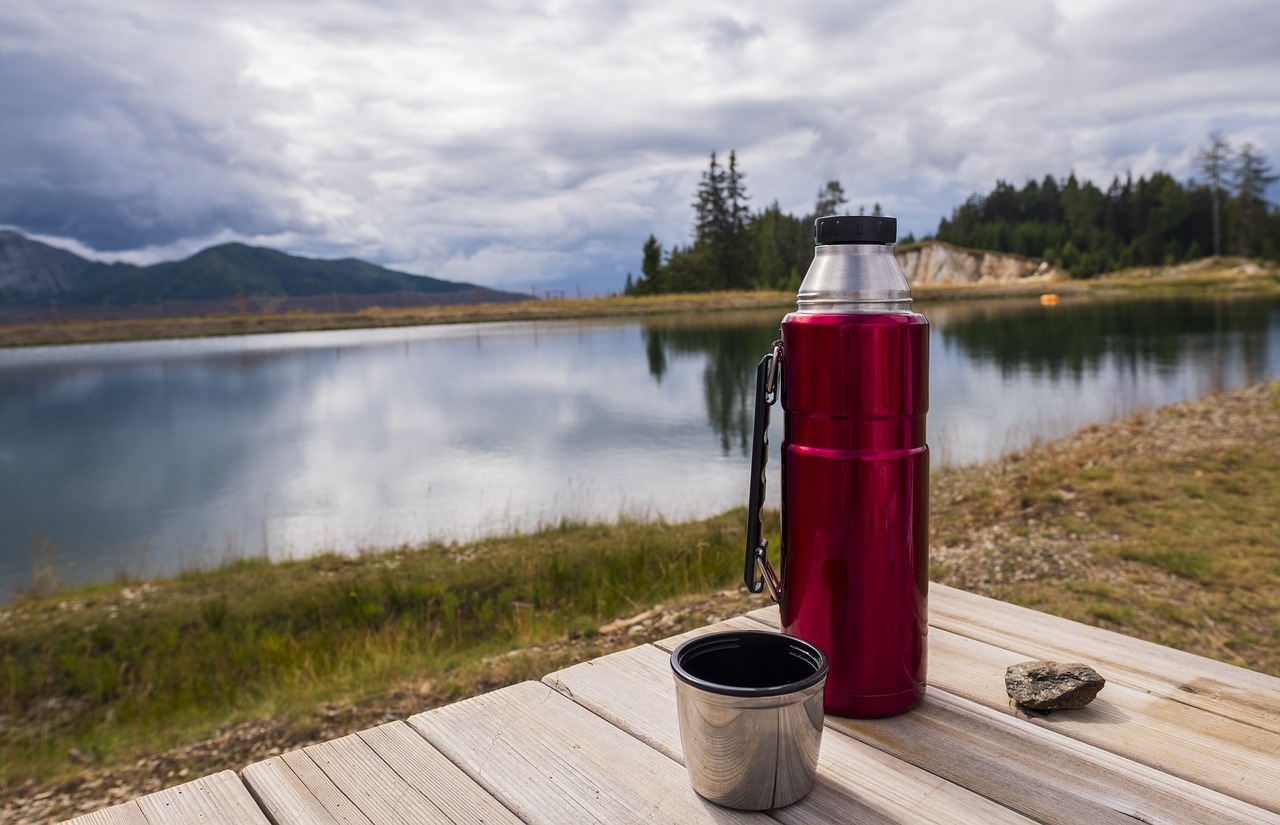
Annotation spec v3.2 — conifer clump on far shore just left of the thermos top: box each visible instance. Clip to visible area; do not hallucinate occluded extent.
[625,151,906,295]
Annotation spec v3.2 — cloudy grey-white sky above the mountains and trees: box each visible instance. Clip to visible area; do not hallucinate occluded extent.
[0,0,1280,295]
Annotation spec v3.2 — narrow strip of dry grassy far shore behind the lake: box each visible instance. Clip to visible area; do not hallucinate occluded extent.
[0,258,1280,347]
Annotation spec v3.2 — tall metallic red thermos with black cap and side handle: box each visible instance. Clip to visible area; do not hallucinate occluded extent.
[745,216,929,718]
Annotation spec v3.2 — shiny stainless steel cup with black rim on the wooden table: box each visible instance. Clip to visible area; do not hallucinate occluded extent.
[671,631,827,811]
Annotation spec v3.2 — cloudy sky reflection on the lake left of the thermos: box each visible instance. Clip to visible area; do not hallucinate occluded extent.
[0,322,757,596]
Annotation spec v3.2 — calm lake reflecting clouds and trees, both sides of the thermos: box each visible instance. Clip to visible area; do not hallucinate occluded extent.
[0,295,1280,602]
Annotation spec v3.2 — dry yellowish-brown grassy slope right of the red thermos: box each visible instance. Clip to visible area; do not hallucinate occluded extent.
[933,382,1280,675]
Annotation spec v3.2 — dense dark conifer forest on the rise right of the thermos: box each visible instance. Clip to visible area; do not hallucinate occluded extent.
[936,133,1280,278]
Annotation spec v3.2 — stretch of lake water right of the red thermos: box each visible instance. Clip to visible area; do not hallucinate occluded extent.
[924,295,1280,466]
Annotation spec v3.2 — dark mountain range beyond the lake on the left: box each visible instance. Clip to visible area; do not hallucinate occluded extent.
[0,230,529,317]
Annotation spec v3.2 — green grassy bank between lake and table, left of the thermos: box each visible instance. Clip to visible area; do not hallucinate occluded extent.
[0,512,745,787]
